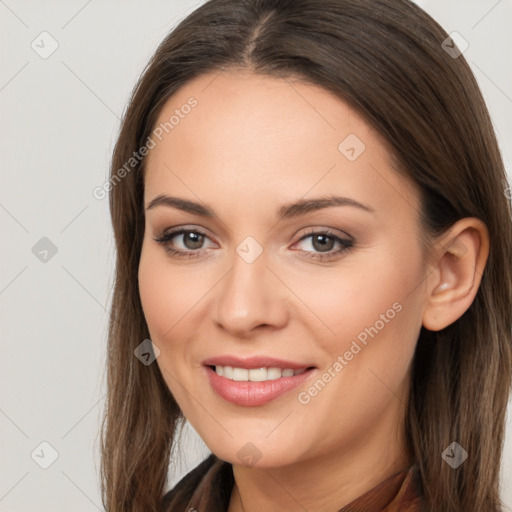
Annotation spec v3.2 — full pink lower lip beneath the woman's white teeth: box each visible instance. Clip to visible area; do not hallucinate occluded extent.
[205,366,315,407]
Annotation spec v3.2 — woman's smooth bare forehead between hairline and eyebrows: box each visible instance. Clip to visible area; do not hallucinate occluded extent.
[145,67,418,218]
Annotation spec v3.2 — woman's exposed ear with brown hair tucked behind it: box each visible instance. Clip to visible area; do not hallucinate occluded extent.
[423,217,489,331]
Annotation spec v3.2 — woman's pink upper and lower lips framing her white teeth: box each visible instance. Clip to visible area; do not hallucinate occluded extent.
[203,355,316,407]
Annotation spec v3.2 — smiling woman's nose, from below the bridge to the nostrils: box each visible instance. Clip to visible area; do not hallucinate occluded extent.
[216,247,289,338]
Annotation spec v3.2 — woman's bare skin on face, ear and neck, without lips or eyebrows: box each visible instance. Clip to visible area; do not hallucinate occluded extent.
[139,71,488,512]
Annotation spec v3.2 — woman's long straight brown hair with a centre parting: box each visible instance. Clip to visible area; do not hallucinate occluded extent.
[101,0,512,512]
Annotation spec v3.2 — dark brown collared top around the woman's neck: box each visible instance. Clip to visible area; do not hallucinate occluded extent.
[160,454,423,512]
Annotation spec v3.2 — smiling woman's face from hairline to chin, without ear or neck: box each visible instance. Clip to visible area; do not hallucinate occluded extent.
[139,72,427,467]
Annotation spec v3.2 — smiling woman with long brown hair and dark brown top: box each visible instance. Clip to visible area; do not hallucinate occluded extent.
[102,0,512,512]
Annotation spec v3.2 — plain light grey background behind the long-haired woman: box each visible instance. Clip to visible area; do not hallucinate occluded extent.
[0,0,512,512]
